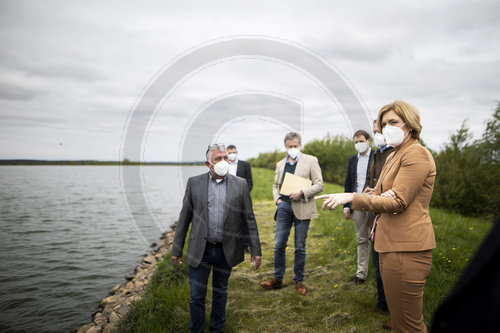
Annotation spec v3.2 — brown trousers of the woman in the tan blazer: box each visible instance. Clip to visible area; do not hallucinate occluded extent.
[379,250,432,333]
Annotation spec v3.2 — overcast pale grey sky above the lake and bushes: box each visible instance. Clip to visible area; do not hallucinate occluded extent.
[0,0,500,161]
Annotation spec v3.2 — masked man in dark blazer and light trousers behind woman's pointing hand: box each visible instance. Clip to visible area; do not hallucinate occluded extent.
[344,130,373,285]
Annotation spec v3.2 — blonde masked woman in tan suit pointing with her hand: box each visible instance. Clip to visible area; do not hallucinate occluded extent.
[316,101,436,332]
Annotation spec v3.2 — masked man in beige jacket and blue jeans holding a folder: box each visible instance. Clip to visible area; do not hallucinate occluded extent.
[261,132,323,295]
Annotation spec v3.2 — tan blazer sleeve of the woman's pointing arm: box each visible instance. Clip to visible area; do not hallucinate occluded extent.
[352,146,435,213]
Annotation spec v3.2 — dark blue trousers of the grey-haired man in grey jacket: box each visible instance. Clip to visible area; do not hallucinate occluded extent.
[189,246,231,332]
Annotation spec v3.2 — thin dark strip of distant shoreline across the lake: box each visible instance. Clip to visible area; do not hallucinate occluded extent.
[0,159,205,166]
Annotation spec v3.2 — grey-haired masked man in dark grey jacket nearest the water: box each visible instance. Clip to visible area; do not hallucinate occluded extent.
[172,144,262,332]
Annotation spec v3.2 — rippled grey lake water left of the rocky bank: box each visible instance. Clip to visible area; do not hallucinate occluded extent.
[0,166,207,332]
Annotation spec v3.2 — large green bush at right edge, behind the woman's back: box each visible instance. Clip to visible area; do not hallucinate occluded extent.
[431,103,500,217]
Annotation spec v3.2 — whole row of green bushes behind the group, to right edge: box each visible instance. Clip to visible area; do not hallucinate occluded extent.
[249,102,500,217]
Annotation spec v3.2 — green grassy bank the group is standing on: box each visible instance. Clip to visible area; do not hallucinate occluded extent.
[118,169,491,332]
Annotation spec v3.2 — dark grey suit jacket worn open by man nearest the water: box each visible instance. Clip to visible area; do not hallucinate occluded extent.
[172,172,261,267]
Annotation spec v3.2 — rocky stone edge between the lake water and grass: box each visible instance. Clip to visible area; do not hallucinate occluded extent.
[71,227,175,333]
